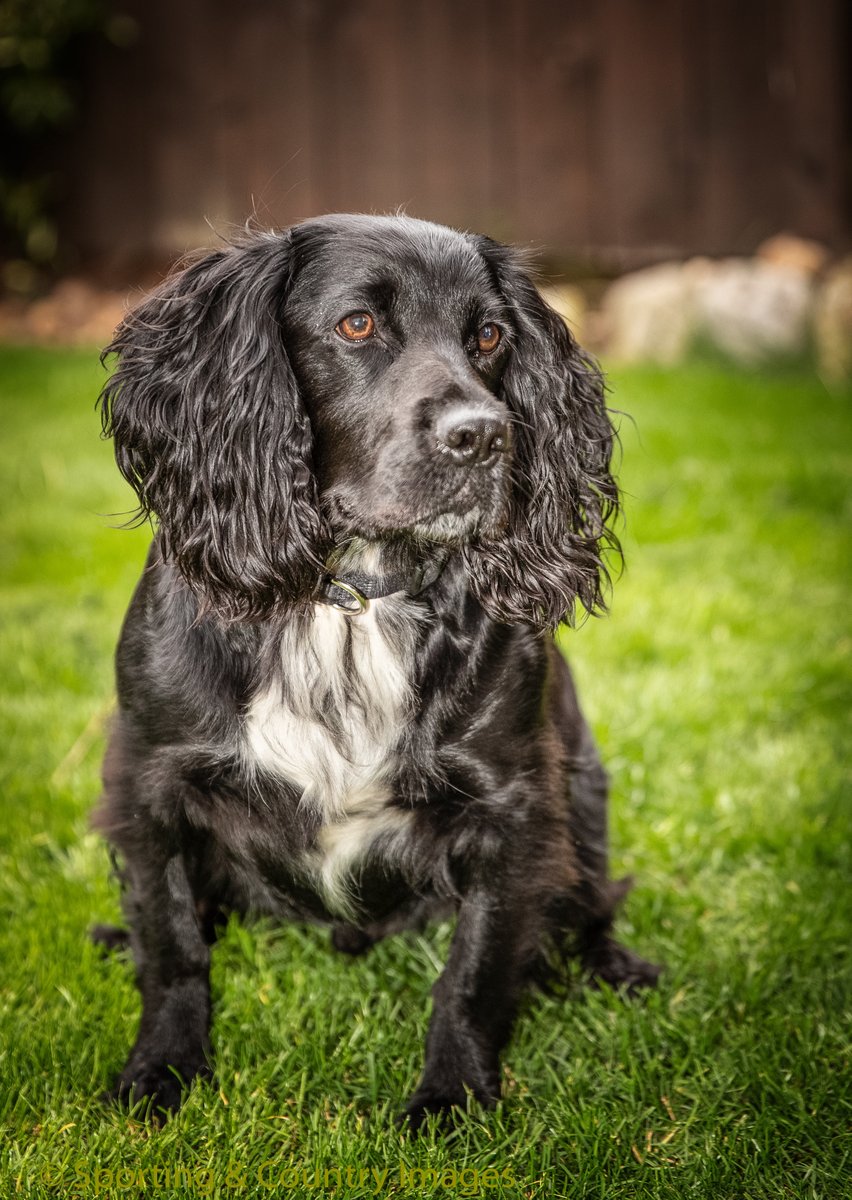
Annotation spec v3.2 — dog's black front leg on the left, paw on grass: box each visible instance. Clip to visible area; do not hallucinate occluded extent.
[110,839,211,1110]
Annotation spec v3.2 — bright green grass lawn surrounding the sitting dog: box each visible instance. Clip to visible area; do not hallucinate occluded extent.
[0,349,852,1200]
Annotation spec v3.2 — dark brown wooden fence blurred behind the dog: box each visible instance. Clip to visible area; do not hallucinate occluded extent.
[64,0,852,269]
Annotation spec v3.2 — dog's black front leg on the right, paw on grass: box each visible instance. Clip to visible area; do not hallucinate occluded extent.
[406,892,534,1130]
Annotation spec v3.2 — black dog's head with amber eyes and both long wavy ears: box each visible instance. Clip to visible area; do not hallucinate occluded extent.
[102,216,618,628]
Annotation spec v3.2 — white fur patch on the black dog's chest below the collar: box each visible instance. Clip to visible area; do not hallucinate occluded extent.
[244,596,422,913]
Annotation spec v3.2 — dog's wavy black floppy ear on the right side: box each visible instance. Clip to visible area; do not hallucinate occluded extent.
[467,238,618,629]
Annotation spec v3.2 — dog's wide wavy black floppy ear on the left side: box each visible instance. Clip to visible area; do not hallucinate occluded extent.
[101,234,322,619]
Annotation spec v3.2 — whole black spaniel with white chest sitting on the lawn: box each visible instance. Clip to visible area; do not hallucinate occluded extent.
[98,216,658,1128]
